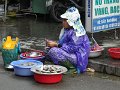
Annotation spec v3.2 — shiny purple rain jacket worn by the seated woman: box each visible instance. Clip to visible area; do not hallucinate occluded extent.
[59,29,90,73]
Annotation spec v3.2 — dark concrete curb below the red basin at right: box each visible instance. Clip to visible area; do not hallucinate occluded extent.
[88,58,120,76]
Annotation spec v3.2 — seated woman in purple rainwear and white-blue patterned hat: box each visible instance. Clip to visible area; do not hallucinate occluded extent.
[47,7,90,73]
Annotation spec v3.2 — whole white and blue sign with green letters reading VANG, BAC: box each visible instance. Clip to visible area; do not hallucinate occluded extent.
[86,0,120,33]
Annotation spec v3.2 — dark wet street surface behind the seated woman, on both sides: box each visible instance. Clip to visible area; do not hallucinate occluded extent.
[0,16,120,49]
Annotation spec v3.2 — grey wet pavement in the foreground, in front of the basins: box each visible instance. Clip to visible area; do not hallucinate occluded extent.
[0,53,120,90]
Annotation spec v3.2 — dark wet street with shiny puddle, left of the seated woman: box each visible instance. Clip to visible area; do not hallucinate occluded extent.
[0,18,61,49]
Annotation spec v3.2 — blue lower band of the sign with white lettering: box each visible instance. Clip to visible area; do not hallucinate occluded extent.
[92,15,120,32]
